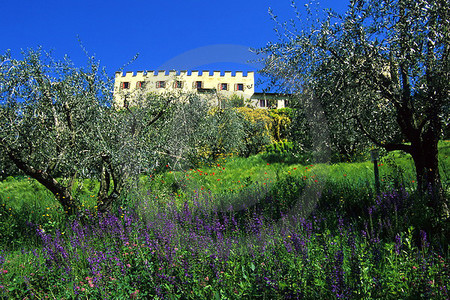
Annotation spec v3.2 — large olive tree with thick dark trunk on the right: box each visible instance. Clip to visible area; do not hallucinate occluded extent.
[260,0,450,208]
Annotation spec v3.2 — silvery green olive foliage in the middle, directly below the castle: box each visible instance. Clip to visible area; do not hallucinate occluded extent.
[133,93,244,169]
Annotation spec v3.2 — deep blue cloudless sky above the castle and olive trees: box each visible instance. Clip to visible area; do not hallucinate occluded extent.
[0,0,348,90]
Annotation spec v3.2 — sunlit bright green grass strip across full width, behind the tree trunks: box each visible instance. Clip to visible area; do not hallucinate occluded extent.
[0,141,450,210]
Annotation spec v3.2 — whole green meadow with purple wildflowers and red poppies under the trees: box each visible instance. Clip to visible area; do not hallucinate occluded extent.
[0,144,450,299]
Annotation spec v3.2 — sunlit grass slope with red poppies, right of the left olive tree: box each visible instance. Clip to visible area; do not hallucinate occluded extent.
[148,141,450,197]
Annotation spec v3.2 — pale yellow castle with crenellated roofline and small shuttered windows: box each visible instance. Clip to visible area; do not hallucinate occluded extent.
[114,71,288,108]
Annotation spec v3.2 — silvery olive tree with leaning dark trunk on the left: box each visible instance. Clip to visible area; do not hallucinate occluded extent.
[0,50,173,214]
